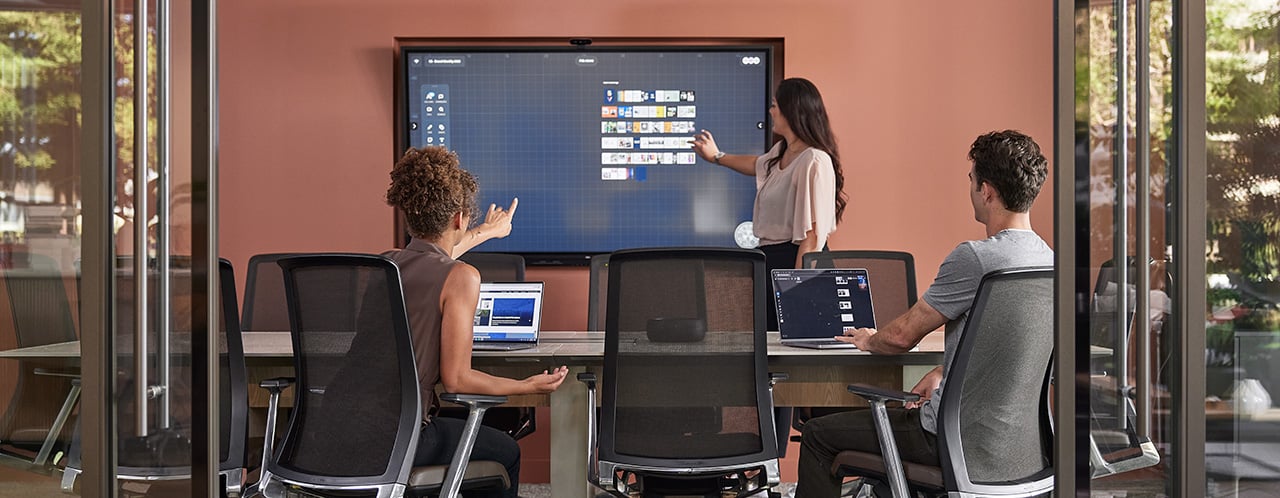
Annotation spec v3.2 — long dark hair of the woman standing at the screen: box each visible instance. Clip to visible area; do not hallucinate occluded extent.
[767,78,849,221]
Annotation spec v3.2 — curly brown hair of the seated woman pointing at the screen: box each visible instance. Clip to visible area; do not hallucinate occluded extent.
[387,146,479,239]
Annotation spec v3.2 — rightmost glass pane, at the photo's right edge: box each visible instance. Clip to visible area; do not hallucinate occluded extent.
[1202,0,1280,497]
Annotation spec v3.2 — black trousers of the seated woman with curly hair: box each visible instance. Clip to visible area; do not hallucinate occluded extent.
[413,417,520,498]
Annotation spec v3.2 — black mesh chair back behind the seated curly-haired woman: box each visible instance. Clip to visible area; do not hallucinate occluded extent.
[268,255,421,485]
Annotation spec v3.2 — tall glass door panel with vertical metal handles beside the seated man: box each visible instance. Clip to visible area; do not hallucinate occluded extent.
[1075,0,1185,495]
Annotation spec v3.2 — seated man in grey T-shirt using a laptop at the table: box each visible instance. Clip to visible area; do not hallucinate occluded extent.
[796,131,1053,497]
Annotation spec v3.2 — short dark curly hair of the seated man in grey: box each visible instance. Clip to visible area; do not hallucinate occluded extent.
[969,129,1048,213]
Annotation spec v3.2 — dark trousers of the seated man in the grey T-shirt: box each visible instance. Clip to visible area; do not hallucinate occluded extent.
[796,408,941,498]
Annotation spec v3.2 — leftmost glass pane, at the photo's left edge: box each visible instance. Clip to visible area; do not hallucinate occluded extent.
[0,1,84,497]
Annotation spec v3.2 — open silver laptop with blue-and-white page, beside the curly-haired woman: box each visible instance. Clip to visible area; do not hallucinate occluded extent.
[471,282,543,351]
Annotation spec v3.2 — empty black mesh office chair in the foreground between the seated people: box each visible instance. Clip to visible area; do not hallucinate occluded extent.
[579,248,780,497]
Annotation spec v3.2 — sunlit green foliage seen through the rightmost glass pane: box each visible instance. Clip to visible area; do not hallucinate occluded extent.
[1204,0,1280,283]
